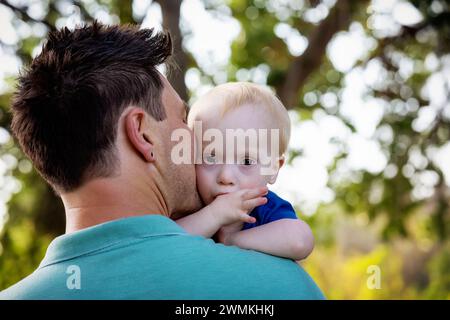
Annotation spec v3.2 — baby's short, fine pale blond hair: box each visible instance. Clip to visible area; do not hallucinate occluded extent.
[188,82,291,155]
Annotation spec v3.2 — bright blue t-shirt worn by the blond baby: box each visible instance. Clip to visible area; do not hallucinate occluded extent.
[242,191,297,230]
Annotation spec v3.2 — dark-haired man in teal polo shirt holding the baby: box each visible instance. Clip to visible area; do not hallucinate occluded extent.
[0,22,323,299]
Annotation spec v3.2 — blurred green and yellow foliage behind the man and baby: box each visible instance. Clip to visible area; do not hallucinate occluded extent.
[0,0,450,299]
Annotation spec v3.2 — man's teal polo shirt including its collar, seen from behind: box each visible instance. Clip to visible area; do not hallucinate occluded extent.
[0,214,324,299]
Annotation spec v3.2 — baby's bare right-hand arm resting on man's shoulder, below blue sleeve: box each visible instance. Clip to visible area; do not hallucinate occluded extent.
[218,219,314,260]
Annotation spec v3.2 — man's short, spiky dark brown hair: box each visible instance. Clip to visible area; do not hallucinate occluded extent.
[11,22,172,192]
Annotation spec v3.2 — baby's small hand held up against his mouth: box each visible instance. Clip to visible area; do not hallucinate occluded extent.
[209,187,268,226]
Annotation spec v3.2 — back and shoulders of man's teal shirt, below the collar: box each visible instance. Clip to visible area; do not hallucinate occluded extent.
[0,234,323,299]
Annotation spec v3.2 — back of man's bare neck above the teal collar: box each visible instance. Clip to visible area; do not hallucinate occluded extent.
[61,178,169,233]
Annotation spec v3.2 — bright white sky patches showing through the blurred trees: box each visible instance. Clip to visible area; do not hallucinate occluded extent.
[0,0,450,225]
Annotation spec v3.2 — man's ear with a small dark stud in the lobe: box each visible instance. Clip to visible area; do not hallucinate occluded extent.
[125,108,155,162]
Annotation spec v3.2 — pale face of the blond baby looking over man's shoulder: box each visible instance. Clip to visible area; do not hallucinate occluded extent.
[196,105,278,204]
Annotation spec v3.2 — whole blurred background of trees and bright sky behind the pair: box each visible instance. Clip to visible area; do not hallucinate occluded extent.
[0,0,450,299]
